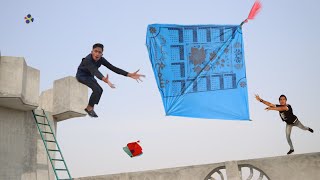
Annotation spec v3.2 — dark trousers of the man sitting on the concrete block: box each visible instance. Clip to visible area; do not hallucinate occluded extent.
[76,76,103,107]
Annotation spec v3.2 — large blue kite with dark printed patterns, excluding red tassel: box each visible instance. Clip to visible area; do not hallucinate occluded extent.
[146,24,249,120]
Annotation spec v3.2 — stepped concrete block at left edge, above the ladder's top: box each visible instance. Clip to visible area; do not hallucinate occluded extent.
[0,56,40,111]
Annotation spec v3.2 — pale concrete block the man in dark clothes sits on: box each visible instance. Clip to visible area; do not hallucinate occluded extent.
[53,76,88,121]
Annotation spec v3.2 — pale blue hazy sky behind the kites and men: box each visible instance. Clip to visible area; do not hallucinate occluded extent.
[0,0,320,177]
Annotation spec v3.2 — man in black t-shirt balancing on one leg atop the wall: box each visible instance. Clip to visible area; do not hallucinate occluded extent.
[256,94,313,154]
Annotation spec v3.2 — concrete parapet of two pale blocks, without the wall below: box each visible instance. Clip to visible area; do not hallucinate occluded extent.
[0,56,88,121]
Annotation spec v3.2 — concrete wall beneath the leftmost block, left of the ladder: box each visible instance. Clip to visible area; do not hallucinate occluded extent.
[0,107,56,180]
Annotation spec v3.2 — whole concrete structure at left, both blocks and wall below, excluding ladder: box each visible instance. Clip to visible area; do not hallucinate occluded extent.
[0,56,88,180]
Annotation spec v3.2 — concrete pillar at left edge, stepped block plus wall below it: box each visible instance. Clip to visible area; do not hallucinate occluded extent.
[0,56,55,180]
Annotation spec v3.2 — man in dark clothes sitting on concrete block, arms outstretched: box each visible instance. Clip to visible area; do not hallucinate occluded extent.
[76,43,145,117]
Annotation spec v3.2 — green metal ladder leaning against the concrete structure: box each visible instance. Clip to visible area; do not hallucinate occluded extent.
[32,109,72,180]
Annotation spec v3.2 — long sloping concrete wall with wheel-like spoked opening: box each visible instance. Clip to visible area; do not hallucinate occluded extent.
[75,153,320,180]
